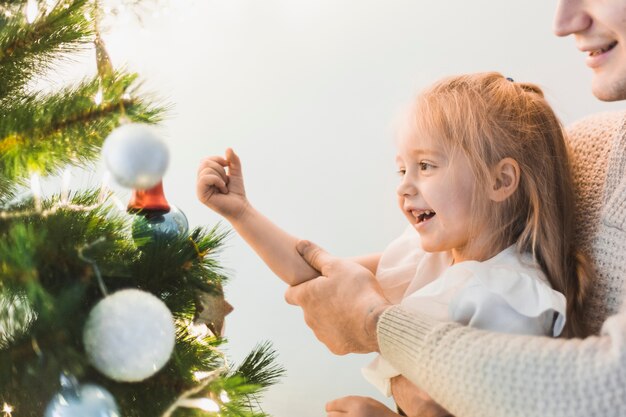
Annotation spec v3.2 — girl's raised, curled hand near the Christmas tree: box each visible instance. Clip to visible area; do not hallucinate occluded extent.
[196,148,249,221]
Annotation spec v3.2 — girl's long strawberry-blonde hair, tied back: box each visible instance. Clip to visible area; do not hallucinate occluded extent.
[414,72,591,337]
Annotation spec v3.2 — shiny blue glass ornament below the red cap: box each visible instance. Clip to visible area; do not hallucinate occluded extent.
[133,206,189,243]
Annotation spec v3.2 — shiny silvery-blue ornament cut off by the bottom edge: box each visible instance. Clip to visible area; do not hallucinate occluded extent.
[44,375,121,417]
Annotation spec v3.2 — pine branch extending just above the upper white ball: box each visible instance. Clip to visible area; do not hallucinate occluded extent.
[0,73,166,184]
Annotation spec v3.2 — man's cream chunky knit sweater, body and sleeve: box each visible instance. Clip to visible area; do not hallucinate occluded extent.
[378,113,626,417]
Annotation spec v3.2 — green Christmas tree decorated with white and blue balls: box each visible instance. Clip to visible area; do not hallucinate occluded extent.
[0,0,282,417]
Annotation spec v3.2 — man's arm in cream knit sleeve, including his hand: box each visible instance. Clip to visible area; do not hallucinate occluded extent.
[285,242,626,417]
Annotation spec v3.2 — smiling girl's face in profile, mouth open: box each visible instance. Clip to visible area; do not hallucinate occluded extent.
[396,128,478,263]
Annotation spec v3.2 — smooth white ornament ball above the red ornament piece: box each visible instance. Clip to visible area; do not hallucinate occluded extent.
[102,123,169,190]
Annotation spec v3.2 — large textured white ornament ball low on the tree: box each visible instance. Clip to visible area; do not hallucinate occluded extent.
[83,289,176,382]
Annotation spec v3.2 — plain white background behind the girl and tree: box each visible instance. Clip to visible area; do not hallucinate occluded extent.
[59,0,621,417]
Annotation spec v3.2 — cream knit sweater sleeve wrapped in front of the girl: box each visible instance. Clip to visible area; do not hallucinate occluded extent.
[378,306,626,417]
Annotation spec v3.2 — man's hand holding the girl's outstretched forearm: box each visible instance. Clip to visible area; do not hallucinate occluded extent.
[285,241,391,355]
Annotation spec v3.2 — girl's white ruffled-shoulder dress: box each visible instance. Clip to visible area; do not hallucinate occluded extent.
[363,227,565,396]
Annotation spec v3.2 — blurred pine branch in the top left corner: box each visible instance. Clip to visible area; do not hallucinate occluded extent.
[0,0,93,100]
